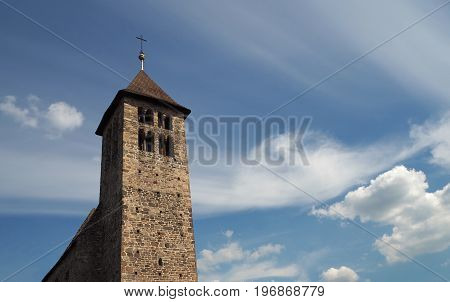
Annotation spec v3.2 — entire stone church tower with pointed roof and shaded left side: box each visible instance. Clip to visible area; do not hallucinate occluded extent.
[43,52,197,281]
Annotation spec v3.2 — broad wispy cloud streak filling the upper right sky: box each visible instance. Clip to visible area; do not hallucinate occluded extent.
[160,0,450,104]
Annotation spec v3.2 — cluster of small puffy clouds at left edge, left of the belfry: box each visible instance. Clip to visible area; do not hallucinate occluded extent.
[0,94,84,138]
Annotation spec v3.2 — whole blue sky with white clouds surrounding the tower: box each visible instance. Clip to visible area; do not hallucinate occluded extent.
[0,0,450,281]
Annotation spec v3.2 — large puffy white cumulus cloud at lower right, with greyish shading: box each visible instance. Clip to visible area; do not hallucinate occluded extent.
[313,166,450,263]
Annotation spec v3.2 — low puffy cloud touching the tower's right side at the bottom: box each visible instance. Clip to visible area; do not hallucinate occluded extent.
[197,231,301,281]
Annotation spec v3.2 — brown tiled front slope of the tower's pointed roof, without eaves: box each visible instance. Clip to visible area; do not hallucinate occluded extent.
[126,70,178,105]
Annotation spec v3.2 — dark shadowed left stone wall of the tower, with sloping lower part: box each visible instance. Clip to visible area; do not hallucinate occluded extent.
[43,106,123,281]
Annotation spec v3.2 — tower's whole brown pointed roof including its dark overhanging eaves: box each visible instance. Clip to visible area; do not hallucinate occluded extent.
[95,70,191,136]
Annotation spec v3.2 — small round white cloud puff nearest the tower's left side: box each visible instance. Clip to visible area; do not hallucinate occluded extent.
[46,102,84,131]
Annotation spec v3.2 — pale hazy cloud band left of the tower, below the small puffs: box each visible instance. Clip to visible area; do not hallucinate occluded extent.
[0,148,100,204]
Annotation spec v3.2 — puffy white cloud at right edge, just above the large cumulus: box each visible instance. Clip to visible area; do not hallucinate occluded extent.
[410,112,450,169]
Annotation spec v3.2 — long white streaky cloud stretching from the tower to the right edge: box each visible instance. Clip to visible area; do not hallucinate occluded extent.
[192,113,450,214]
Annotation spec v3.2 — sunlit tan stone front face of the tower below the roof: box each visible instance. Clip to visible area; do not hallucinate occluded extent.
[121,99,197,281]
